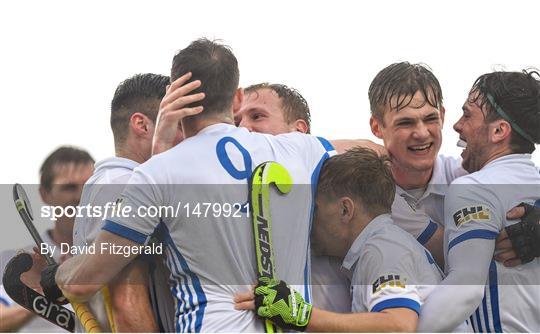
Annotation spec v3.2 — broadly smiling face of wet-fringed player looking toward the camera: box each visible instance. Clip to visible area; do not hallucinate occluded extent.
[371,92,444,175]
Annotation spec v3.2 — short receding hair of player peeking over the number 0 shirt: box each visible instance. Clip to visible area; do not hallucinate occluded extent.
[244,82,311,133]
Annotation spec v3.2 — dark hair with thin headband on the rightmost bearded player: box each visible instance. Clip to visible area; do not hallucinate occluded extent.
[469,70,540,153]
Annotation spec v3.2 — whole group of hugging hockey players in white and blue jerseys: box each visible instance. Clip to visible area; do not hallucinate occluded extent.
[0,38,540,332]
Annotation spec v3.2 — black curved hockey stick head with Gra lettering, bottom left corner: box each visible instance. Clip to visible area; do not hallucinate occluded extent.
[2,253,75,333]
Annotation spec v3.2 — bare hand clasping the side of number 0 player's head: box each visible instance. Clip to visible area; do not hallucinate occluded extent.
[152,72,204,155]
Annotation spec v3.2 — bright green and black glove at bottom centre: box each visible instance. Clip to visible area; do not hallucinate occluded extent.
[255,277,313,332]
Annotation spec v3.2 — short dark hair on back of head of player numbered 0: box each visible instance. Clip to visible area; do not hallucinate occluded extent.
[171,38,240,117]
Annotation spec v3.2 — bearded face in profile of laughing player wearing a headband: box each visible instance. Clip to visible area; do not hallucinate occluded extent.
[454,92,489,173]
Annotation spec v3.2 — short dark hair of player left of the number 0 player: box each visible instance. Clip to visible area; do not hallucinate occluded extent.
[111,73,170,146]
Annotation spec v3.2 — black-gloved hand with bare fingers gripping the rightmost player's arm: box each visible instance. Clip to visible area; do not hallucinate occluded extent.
[494,203,540,267]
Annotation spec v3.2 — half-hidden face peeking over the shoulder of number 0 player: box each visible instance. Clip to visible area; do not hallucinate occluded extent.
[234,88,295,135]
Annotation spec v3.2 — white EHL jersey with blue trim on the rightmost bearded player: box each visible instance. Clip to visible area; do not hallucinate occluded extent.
[445,154,540,332]
